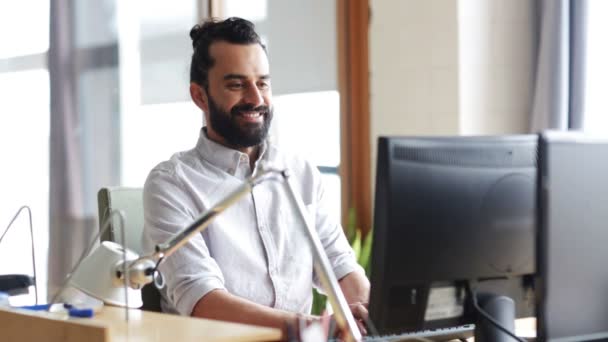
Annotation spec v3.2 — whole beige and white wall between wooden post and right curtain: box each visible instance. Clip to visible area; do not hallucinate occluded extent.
[369,0,536,190]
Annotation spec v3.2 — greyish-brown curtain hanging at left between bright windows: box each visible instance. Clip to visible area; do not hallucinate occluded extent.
[47,0,95,299]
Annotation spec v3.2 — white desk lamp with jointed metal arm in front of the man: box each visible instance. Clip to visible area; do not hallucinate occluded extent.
[65,165,361,341]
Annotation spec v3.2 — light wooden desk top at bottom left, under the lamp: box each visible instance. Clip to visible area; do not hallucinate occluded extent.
[0,306,281,342]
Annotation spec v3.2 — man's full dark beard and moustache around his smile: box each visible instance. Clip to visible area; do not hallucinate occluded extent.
[207,96,273,148]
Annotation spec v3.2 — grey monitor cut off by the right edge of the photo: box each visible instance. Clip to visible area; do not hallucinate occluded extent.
[535,132,608,341]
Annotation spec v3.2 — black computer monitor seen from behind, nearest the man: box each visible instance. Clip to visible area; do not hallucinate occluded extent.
[369,135,538,340]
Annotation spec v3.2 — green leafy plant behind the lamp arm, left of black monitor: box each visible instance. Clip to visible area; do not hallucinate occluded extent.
[311,208,373,315]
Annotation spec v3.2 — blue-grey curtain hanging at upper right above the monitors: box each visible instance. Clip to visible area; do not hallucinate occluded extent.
[531,0,587,132]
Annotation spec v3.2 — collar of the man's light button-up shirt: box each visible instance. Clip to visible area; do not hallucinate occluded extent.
[196,127,268,175]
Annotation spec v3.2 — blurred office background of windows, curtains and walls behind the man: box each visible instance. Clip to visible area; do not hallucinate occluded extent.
[0,0,608,304]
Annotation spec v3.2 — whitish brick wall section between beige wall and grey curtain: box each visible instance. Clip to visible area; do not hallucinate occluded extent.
[458,0,536,134]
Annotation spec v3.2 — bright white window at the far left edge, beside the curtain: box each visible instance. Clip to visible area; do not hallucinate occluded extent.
[0,0,50,305]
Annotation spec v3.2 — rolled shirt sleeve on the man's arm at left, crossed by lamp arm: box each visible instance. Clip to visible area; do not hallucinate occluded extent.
[142,167,225,316]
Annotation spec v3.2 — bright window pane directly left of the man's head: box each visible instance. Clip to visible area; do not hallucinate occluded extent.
[119,0,203,187]
